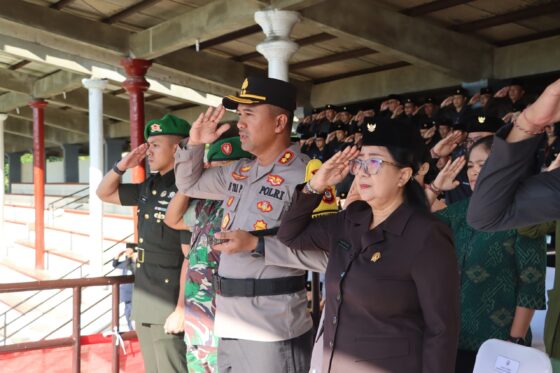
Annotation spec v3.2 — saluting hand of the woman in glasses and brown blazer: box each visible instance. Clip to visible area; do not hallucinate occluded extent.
[309,146,360,193]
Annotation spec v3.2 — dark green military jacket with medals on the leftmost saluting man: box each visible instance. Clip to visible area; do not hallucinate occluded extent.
[118,170,183,324]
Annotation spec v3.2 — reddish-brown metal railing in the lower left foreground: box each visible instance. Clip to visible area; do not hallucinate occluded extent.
[0,276,136,373]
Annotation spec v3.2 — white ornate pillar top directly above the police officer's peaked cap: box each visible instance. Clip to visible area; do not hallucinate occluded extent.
[255,10,300,82]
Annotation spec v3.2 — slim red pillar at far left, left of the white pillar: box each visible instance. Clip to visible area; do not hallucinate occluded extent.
[29,99,47,269]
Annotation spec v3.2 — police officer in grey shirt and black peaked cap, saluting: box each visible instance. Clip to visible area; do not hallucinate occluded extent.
[175,77,312,373]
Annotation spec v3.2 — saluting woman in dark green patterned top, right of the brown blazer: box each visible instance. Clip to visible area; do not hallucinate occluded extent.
[427,136,546,373]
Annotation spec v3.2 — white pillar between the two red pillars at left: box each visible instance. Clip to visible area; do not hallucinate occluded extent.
[82,79,108,276]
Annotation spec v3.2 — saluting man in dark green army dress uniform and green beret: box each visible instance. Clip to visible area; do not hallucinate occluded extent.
[97,115,190,373]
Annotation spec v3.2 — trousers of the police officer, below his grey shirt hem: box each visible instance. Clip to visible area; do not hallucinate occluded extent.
[218,330,313,373]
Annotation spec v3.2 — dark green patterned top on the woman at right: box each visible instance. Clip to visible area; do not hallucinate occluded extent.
[436,199,546,351]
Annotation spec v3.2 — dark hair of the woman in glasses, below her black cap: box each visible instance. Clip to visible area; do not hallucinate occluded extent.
[387,146,430,211]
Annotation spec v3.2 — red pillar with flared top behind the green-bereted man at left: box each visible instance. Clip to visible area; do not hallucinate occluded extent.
[121,58,152,183]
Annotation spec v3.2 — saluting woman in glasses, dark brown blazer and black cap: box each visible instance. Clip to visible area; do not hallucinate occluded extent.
[278,120,459,373]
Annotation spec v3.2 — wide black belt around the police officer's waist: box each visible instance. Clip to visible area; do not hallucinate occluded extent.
[212,274,306,297]
